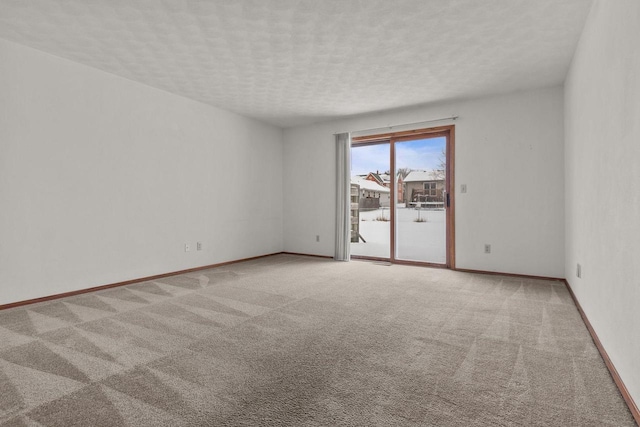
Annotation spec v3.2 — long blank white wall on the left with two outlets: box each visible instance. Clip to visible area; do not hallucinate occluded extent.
[0,40,282,304]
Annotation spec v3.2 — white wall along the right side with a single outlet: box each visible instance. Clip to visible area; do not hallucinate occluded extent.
[565,0,640,403]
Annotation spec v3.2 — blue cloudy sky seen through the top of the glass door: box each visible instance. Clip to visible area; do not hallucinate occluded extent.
[351,137,446,175]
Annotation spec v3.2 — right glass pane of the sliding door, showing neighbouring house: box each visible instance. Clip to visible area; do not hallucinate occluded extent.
[395,137,447,264]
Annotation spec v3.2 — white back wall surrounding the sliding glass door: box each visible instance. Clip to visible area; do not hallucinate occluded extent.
[284,87,564,277]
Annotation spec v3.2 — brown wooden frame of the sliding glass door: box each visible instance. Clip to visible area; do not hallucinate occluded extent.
[351,125,456,269]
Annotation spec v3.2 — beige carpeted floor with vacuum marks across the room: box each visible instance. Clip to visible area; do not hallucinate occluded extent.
[0,255,635,427]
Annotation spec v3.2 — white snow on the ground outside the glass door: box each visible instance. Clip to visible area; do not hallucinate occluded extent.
[351,207,446,264]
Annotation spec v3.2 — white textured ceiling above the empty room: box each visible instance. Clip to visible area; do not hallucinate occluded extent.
[0,0,591,127]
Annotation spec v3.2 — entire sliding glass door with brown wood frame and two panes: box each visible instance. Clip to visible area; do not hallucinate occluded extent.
[351,126,454,267]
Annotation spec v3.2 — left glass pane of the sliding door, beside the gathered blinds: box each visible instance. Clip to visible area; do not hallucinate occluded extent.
[351,143,392,259]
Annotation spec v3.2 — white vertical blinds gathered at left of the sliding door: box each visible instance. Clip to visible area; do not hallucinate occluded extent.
[334,133,351,261]
